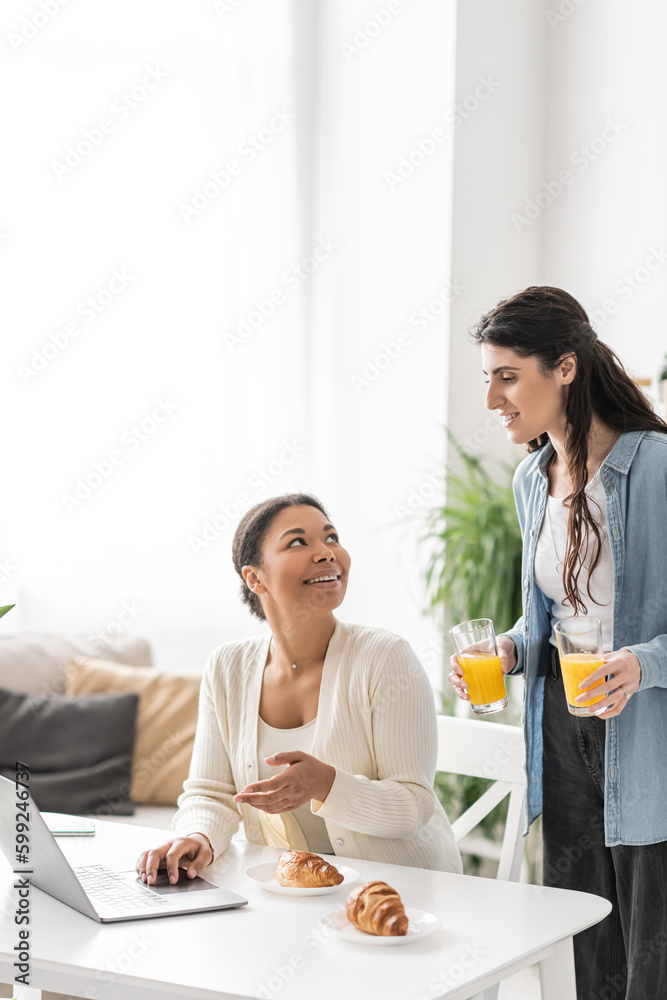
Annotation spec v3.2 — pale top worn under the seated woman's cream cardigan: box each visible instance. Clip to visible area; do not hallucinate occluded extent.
[257,715,334,854]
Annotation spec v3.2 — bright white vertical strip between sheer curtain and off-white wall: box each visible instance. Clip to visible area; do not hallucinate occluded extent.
[308,0,455,681]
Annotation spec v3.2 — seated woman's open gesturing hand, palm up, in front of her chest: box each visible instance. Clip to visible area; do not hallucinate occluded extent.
[234,750,336,813]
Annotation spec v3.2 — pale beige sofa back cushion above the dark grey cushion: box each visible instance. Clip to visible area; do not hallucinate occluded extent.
[0,623,153,695]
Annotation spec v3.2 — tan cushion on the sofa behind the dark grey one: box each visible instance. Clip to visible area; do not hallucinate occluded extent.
[66,657,201,805]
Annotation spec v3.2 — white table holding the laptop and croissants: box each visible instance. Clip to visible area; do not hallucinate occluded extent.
[0,822,611,1000]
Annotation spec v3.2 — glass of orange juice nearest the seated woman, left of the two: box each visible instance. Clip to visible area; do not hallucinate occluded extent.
[449,618,507,715]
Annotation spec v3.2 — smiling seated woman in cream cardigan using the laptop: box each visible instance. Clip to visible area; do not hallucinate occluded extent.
[137,493,461,883]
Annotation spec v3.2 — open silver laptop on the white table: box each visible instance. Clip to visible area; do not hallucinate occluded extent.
[0,775,248,923]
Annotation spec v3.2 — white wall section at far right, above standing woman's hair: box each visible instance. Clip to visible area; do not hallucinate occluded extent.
[542,0,667,398]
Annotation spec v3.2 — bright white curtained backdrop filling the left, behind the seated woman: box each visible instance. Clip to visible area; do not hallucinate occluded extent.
[0,0,454,684]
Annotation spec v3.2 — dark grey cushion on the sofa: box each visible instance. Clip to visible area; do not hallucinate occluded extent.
[0,689,139,816]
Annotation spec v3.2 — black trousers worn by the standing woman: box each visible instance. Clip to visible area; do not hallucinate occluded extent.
[543,648,667,1000]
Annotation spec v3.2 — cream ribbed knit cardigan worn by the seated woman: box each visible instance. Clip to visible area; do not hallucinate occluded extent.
[173,621,461,872]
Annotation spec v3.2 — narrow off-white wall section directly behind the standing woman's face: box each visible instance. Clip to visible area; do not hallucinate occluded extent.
[447,0,548,476]
